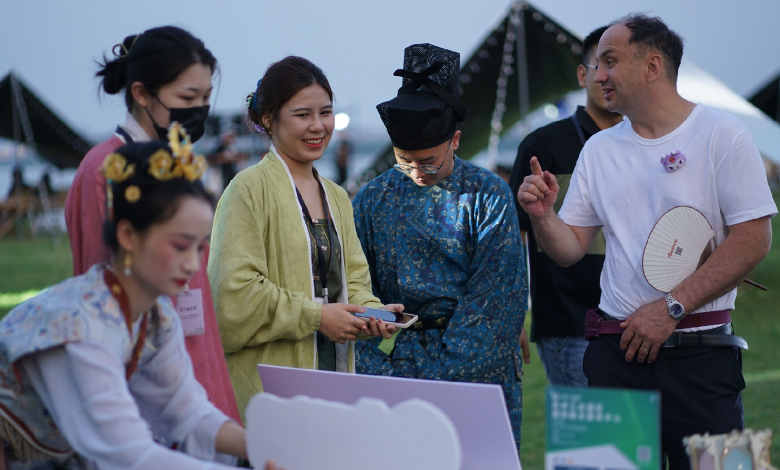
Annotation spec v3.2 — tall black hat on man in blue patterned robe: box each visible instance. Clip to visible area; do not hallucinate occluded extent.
[376,44,469,150]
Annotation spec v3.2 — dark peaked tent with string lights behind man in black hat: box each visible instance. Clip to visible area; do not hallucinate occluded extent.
[350,1,582,190]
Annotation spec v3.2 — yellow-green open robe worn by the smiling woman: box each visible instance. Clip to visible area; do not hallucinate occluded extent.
[208,147,381,417]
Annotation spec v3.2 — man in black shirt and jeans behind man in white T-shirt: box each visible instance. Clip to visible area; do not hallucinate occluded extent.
[509,26,623,387]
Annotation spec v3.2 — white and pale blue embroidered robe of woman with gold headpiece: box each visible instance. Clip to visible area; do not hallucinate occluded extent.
[0,265,235,470]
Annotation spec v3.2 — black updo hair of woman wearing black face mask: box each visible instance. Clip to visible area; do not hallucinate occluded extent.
[95,26,217,111]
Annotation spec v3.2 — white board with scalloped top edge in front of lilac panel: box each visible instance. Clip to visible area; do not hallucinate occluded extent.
[246,393,462,470]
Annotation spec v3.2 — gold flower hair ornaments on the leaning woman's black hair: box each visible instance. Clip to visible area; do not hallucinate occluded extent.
[100,122,207,220]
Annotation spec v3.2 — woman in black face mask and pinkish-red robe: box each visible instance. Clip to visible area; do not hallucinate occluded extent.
[65,26,240,421]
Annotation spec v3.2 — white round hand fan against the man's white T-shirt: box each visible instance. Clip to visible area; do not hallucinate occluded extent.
[642,206,715,292]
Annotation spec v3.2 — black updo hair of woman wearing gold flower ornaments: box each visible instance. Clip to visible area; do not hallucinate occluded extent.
[103,140,215,253]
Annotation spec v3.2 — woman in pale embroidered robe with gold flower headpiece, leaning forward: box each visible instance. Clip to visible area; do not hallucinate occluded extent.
[0,125,280,470]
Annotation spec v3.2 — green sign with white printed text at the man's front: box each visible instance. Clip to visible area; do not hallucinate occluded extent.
[545,387,661,470]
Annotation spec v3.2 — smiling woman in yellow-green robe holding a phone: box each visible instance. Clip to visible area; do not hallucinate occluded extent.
[208,56,403,418]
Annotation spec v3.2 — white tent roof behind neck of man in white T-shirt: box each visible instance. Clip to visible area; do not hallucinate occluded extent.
[677,57,780,164]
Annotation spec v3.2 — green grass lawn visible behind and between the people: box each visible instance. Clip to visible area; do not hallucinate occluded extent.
[0,198,780,470]
